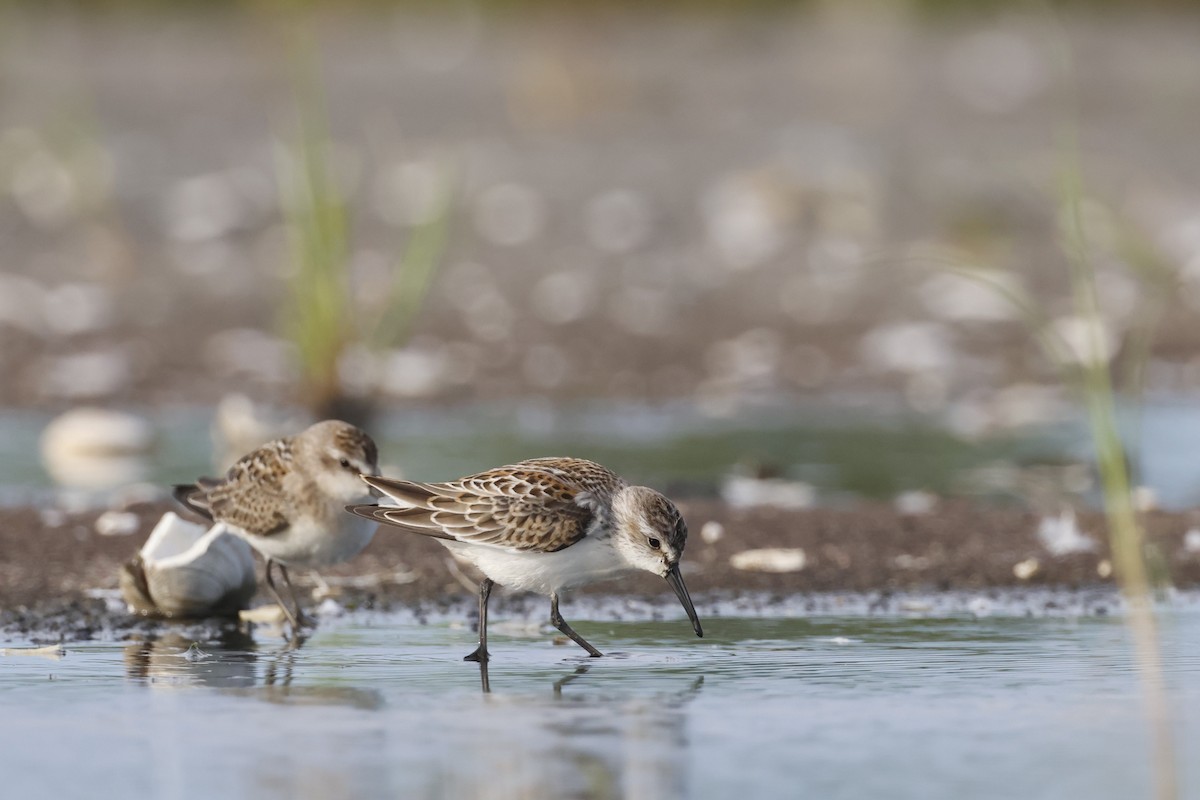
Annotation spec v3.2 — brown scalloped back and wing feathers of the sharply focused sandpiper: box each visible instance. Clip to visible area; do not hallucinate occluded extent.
[355,458,625,553]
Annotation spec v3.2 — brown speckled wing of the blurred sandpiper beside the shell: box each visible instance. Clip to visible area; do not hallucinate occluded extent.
[175,439,292,536]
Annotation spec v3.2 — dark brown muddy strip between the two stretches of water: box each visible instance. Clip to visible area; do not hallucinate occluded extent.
[0,500,1200,640]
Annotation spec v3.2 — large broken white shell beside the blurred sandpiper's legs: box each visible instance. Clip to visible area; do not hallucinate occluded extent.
[121,511,258,619]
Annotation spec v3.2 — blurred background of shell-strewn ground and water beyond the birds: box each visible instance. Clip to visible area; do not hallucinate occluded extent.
[7,0,1200,507]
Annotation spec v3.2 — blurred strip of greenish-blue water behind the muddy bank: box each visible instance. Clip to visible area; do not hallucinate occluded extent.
[11,396,1200,509]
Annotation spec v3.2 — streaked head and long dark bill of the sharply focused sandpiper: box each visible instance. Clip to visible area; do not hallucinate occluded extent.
[612,486,704,636]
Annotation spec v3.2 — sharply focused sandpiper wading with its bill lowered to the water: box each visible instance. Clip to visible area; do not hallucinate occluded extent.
[347,458,704,662]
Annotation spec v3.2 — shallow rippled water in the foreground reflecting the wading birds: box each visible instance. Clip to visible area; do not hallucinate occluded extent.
[0,608,1200,799]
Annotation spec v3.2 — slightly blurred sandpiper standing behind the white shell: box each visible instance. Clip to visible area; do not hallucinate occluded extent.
[175,420,379,633]
